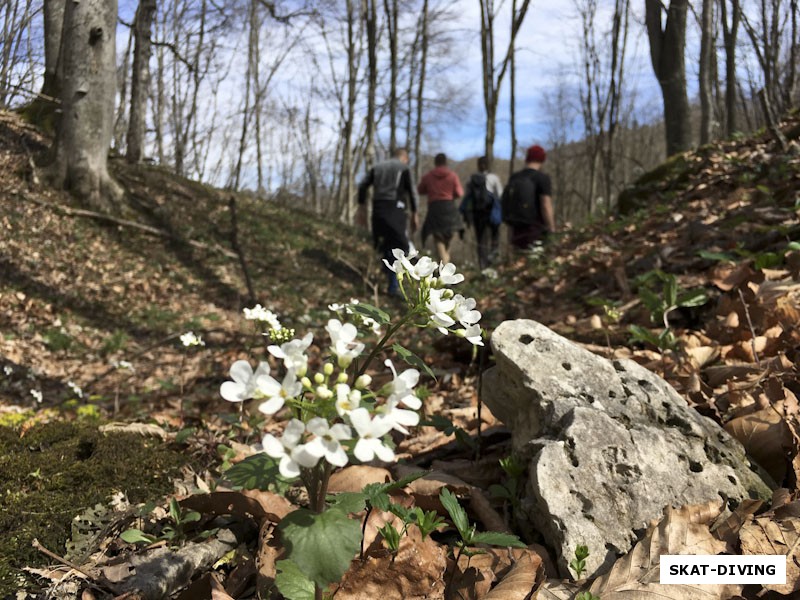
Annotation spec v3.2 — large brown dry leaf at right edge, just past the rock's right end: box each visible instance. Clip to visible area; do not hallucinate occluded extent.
[725,407,791,484]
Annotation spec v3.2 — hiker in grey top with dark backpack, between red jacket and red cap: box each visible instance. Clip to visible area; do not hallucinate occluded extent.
[459,156,503,271]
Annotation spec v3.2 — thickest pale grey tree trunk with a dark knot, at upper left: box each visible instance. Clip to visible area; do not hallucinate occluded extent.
[51,0,122,209]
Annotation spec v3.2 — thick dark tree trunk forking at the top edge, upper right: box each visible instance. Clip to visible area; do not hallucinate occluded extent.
[645,0,692,156]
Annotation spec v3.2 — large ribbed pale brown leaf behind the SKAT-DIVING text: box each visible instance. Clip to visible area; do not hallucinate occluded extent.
[589,501,741,600]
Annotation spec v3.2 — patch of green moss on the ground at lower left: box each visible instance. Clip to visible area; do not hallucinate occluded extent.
[0,422,186,597]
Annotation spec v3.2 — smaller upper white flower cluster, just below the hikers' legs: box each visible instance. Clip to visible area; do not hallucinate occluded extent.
[383,250,483,346]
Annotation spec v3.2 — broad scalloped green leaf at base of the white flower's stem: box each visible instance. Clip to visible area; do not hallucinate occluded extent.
[278,508,361,587]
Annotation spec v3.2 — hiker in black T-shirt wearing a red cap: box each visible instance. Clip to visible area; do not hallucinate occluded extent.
[502,146,556,250]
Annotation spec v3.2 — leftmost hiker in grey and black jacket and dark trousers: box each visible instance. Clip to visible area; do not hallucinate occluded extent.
[356,148,419,296]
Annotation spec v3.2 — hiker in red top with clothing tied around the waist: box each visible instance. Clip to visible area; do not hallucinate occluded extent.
[417,153,464,264]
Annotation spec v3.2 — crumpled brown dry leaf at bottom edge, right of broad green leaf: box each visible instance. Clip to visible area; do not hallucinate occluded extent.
[336,528,447,600]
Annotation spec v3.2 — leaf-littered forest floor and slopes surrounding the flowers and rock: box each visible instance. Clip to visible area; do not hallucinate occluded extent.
[0,109,800,599]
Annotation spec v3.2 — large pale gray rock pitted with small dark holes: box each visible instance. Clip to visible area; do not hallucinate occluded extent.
[482,320,771,576]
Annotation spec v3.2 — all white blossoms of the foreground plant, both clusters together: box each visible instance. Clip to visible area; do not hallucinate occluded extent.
[220,251,483,478]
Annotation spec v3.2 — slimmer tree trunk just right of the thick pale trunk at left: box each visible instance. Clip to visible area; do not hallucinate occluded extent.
[125,0,158,163]
